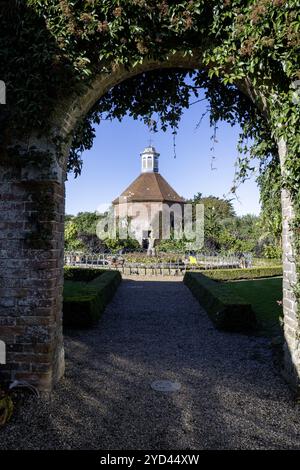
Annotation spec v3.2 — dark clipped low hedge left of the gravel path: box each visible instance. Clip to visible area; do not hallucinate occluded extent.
[63,269,122,328]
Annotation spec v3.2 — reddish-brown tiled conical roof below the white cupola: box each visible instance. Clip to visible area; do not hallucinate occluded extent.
[113,173,184,204]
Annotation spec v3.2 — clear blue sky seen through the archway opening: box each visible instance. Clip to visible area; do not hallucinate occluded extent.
[66,102,260,215]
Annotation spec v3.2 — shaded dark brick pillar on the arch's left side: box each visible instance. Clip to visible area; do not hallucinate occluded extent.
[0,151,64,392]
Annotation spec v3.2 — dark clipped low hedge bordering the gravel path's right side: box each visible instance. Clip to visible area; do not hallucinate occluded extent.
[184,273,256,332]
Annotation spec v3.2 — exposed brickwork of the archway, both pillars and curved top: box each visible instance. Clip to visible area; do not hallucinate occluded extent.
[0,54,300,392]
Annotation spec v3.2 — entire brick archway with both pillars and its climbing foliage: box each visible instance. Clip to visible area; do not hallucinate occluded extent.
[0,0,300,391]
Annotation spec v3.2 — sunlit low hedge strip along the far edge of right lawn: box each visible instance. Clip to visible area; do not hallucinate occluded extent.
[199,266,282,281]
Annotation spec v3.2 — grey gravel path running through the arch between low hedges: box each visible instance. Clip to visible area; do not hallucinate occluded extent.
[0,278,300,450]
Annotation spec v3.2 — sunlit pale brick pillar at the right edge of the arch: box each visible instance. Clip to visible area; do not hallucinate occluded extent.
[279,141,300,390]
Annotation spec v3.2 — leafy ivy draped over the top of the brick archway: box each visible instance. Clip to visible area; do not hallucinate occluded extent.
[0,0,300,302]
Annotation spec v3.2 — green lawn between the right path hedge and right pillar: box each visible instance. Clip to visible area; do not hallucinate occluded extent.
[228,278,282,336]
